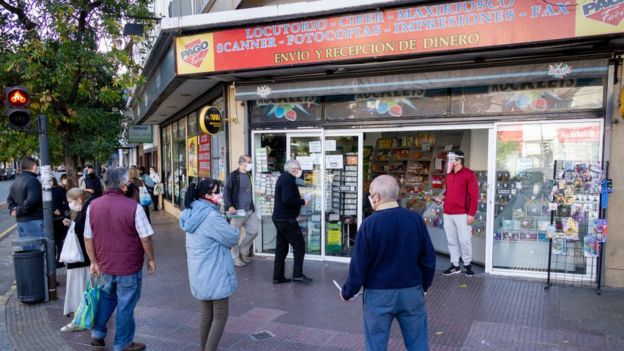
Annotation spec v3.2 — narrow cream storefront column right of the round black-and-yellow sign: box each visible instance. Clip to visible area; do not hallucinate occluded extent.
[226,85,247,170]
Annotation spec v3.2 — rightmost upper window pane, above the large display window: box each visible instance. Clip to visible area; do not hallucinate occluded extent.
[451,78,603,115]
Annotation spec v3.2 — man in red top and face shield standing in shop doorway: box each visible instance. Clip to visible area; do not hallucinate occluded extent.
[438,151,479,277]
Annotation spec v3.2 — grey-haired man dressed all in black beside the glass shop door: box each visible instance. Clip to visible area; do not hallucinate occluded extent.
[272,160,312,284]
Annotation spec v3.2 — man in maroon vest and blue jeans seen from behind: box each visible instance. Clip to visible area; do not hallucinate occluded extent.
[84,168,156,351]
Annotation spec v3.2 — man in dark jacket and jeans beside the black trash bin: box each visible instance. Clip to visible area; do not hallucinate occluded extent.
[7,157,45,249]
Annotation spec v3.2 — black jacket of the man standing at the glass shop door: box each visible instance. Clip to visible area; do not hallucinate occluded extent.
[273,172,305,221]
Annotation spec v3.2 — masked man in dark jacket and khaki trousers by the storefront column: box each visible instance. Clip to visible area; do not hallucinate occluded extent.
[223,155,260,267]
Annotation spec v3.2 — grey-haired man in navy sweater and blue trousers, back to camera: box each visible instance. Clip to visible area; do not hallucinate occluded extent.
[340,175,436,351]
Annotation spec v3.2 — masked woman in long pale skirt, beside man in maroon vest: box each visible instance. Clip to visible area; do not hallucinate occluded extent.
[61,188,91,332]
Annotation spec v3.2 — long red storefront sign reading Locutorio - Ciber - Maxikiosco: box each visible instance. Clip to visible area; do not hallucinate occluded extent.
[176,0,624,75]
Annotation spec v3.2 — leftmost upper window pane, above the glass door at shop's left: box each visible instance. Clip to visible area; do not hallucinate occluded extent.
[251,97,322,124]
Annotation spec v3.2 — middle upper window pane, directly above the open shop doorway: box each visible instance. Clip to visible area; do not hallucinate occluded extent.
[325,89,448,120]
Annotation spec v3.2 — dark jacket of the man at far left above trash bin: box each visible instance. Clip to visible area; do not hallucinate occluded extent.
[7,171,43,222]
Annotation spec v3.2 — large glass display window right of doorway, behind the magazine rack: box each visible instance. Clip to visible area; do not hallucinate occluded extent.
[492,122,602,274]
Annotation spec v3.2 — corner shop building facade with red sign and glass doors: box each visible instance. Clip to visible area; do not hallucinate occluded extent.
[128,0,624,286]
